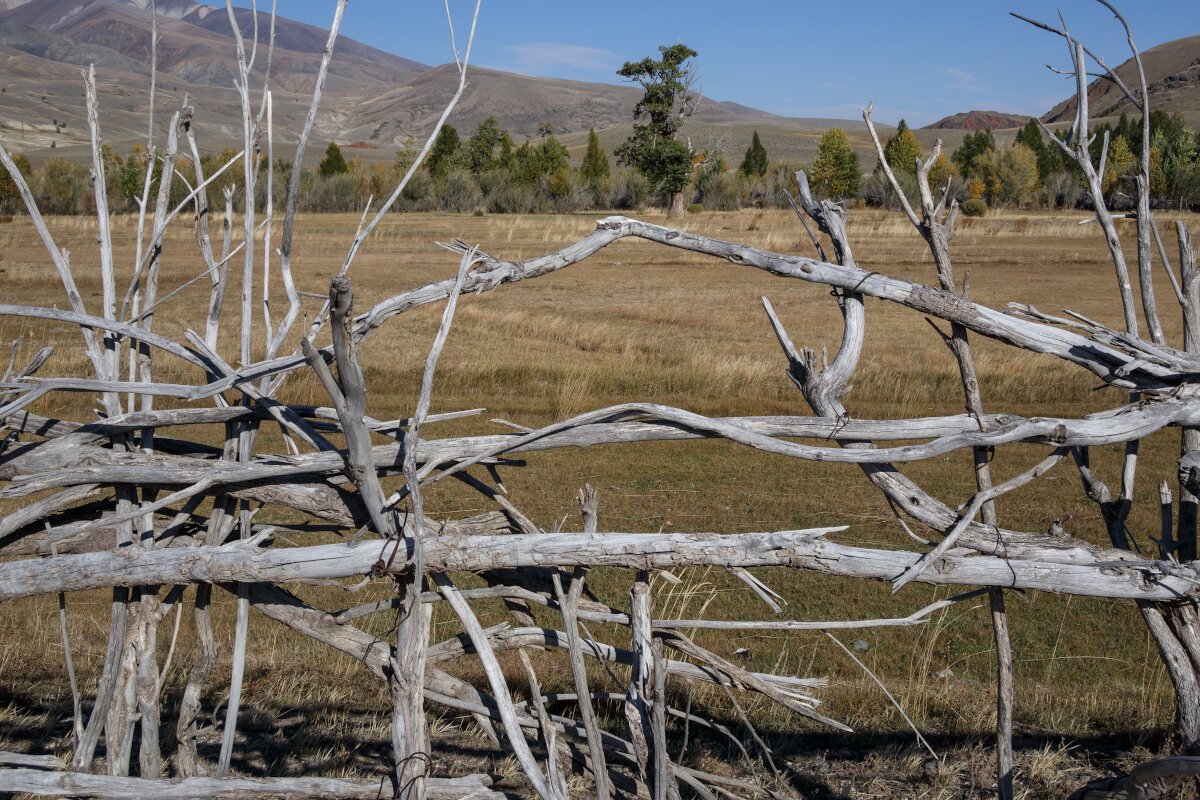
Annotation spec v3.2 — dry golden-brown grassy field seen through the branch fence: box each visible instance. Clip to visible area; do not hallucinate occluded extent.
[0,210,1198,798]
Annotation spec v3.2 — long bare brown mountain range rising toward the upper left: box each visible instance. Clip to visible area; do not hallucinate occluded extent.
[0,0,887,163]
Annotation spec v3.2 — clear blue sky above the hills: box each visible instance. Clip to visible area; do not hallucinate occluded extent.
[229,0,1200,126]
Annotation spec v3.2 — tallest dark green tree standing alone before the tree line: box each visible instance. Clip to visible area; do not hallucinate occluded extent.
[616,44,696,215]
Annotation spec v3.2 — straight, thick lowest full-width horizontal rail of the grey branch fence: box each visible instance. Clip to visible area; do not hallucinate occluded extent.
[9,528,1200,602]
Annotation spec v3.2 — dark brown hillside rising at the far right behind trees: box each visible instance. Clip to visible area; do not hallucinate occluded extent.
[1042,36,1200,125]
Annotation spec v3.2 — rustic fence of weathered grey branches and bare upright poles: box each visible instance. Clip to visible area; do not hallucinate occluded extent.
[0,0,1200,800]
